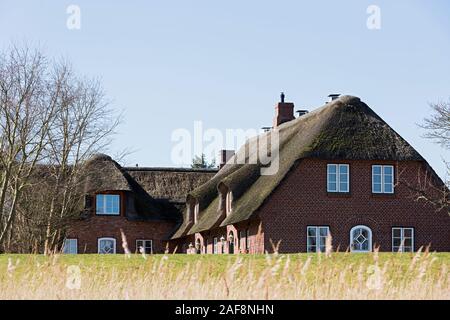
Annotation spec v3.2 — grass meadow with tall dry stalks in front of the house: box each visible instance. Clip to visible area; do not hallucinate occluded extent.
[0,252,450,300]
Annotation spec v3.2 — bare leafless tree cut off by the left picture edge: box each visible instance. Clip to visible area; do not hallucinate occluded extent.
[0,47,58,250]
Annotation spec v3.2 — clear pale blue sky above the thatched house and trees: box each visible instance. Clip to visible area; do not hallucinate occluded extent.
[0,0,450,176]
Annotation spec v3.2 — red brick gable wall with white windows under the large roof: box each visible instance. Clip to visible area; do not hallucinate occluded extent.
[259,159,450,252]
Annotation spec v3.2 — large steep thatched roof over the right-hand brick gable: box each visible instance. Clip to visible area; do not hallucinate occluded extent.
[172,96,424,238]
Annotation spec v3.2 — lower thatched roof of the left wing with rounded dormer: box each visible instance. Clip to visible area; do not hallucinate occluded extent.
[85,154,217,221]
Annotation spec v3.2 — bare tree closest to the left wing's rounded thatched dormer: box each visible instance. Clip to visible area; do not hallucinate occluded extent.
[40,64,121,252]
